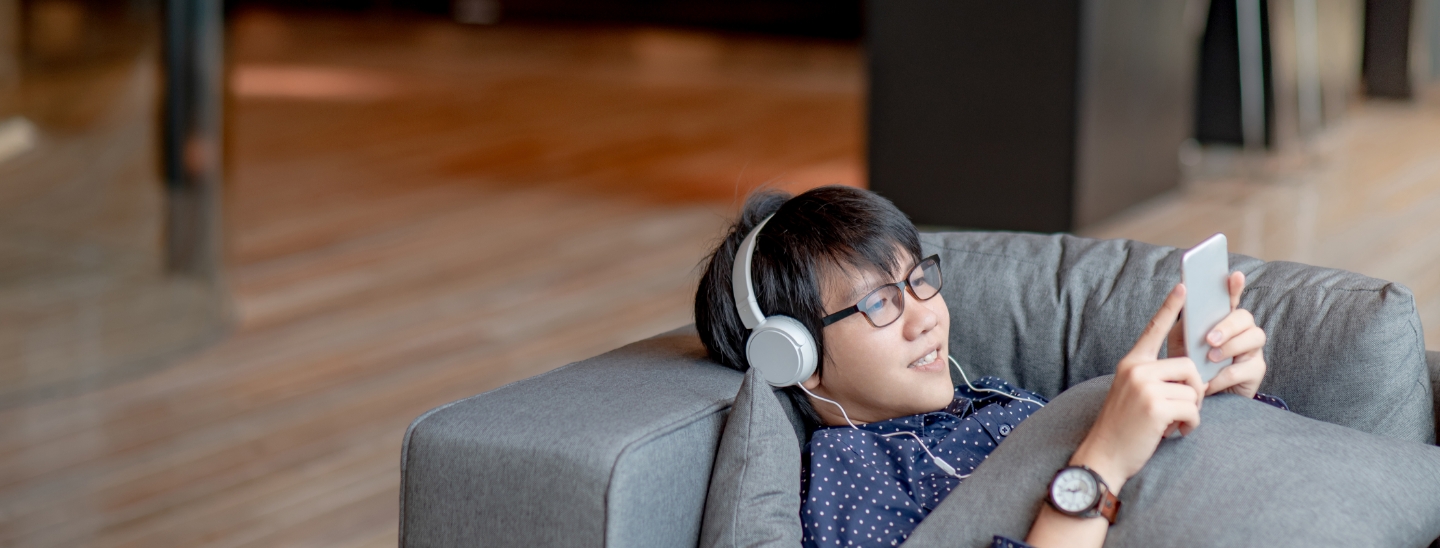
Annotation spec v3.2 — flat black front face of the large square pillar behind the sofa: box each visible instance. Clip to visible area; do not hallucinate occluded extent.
[865,0,1080,232]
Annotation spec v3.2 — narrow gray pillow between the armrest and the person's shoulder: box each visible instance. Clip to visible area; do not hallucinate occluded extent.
[700,370,801,548]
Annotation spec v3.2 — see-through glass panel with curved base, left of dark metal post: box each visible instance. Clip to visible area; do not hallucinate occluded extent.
[0,0,229,406]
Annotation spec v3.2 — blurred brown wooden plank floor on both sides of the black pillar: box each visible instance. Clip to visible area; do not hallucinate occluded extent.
[0,12,1440,547]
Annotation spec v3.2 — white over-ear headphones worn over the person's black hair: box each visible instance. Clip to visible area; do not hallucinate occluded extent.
[730,214,818,387]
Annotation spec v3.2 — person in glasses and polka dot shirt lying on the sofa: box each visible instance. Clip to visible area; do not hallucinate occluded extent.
[696,187,1284,547]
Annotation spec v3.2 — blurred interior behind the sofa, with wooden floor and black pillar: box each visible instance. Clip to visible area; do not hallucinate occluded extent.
[0,0,1440,547]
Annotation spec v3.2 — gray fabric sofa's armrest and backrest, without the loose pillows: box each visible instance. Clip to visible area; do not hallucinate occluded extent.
[400,233,1440,548]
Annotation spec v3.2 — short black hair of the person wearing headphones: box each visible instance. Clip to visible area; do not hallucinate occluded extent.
[696,186,920,426]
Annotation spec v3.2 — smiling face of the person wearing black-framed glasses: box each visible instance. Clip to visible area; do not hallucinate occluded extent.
[804,254,955,426]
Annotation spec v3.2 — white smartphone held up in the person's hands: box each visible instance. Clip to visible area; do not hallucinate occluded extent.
[1179,234,1233,383]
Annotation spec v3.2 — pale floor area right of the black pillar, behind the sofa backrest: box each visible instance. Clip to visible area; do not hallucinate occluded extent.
[1081,86,1440,343]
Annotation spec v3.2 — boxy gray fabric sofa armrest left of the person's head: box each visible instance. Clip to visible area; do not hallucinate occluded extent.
[400,326,743,548]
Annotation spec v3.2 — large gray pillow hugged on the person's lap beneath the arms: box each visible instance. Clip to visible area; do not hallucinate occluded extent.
[906,377,1440,547]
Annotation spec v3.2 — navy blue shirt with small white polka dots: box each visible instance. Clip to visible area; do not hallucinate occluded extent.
[801,377,1286,548]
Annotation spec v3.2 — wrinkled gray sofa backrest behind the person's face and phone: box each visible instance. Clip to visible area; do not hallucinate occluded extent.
[922,232,1436,443]
